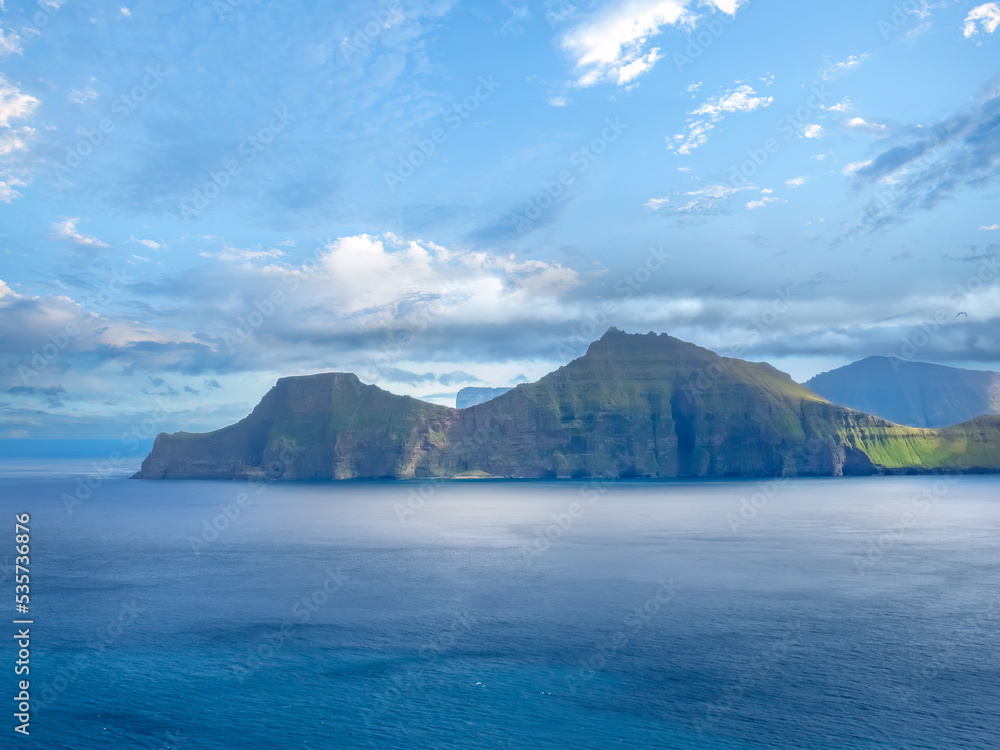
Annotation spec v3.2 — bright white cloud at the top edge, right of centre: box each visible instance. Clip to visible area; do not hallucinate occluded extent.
[561,0,743,86]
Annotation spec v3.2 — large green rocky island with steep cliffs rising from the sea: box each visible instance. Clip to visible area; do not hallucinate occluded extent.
[135,328,1000,479]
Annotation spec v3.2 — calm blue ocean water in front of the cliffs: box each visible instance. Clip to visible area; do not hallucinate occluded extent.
[0,458,1000,750]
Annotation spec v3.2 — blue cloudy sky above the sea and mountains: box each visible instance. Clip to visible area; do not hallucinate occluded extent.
[0,0,1000,438]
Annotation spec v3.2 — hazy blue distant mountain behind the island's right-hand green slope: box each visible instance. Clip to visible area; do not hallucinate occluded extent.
[805,357,1000,427]
